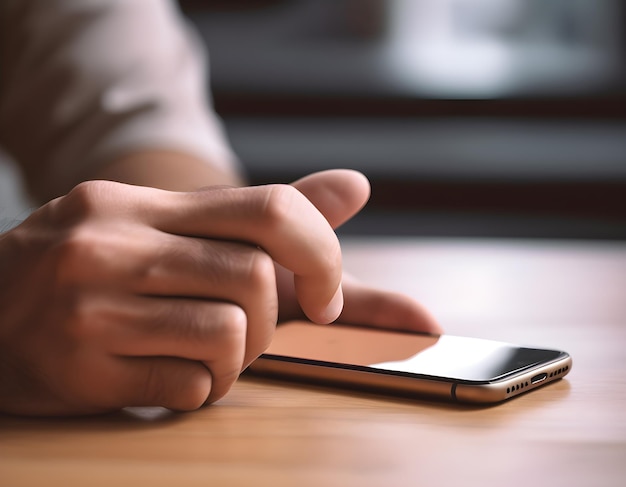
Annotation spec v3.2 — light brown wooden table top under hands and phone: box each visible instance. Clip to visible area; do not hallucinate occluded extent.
[0,238,626,487]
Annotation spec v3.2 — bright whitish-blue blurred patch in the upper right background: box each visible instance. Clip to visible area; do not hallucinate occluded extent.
[387,0,623,98]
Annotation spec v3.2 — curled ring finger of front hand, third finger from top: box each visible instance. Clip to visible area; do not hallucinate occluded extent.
[93,298,249,402]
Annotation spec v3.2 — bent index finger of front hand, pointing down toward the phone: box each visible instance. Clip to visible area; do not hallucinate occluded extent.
[138,185,343,323]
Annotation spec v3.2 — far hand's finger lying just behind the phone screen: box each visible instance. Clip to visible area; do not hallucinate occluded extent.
[339,276,443,334]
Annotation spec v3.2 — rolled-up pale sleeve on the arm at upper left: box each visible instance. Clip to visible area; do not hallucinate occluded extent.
[0,0,236,202]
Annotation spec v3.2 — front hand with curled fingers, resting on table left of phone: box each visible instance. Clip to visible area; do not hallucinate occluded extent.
[0,175,342,415]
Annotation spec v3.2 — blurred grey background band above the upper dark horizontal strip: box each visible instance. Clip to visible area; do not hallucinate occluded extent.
[193,0,626,98]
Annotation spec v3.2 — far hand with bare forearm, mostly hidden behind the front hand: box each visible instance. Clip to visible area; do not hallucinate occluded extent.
[94,151,441,333]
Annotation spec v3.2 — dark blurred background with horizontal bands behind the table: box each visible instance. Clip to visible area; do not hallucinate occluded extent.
[0,0,626,239]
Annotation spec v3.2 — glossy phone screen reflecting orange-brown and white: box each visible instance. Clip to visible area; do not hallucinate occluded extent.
[266,322,562,382]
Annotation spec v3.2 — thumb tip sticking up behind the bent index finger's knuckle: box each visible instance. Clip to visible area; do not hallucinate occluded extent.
[292,169,370,228]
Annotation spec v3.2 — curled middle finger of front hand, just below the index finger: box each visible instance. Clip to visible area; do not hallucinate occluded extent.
[134,236,278,367]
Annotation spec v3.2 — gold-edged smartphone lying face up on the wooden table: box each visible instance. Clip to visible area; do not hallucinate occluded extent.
[249,321,572,403]
